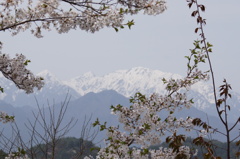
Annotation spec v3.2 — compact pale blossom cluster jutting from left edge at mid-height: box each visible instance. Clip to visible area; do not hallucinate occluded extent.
[0,54,44,93]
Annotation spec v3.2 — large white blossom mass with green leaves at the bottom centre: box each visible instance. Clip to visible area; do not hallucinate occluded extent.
[93,90,193,158]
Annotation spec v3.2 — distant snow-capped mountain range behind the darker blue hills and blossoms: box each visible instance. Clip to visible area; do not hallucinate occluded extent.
[0,67,240,120]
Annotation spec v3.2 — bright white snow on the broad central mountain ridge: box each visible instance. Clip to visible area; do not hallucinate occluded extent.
[64,67,181,97]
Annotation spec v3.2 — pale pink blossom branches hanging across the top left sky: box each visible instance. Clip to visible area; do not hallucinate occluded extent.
[0,0,166,35]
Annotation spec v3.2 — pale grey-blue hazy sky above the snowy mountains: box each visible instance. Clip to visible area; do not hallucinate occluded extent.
[0,0,240,92]
